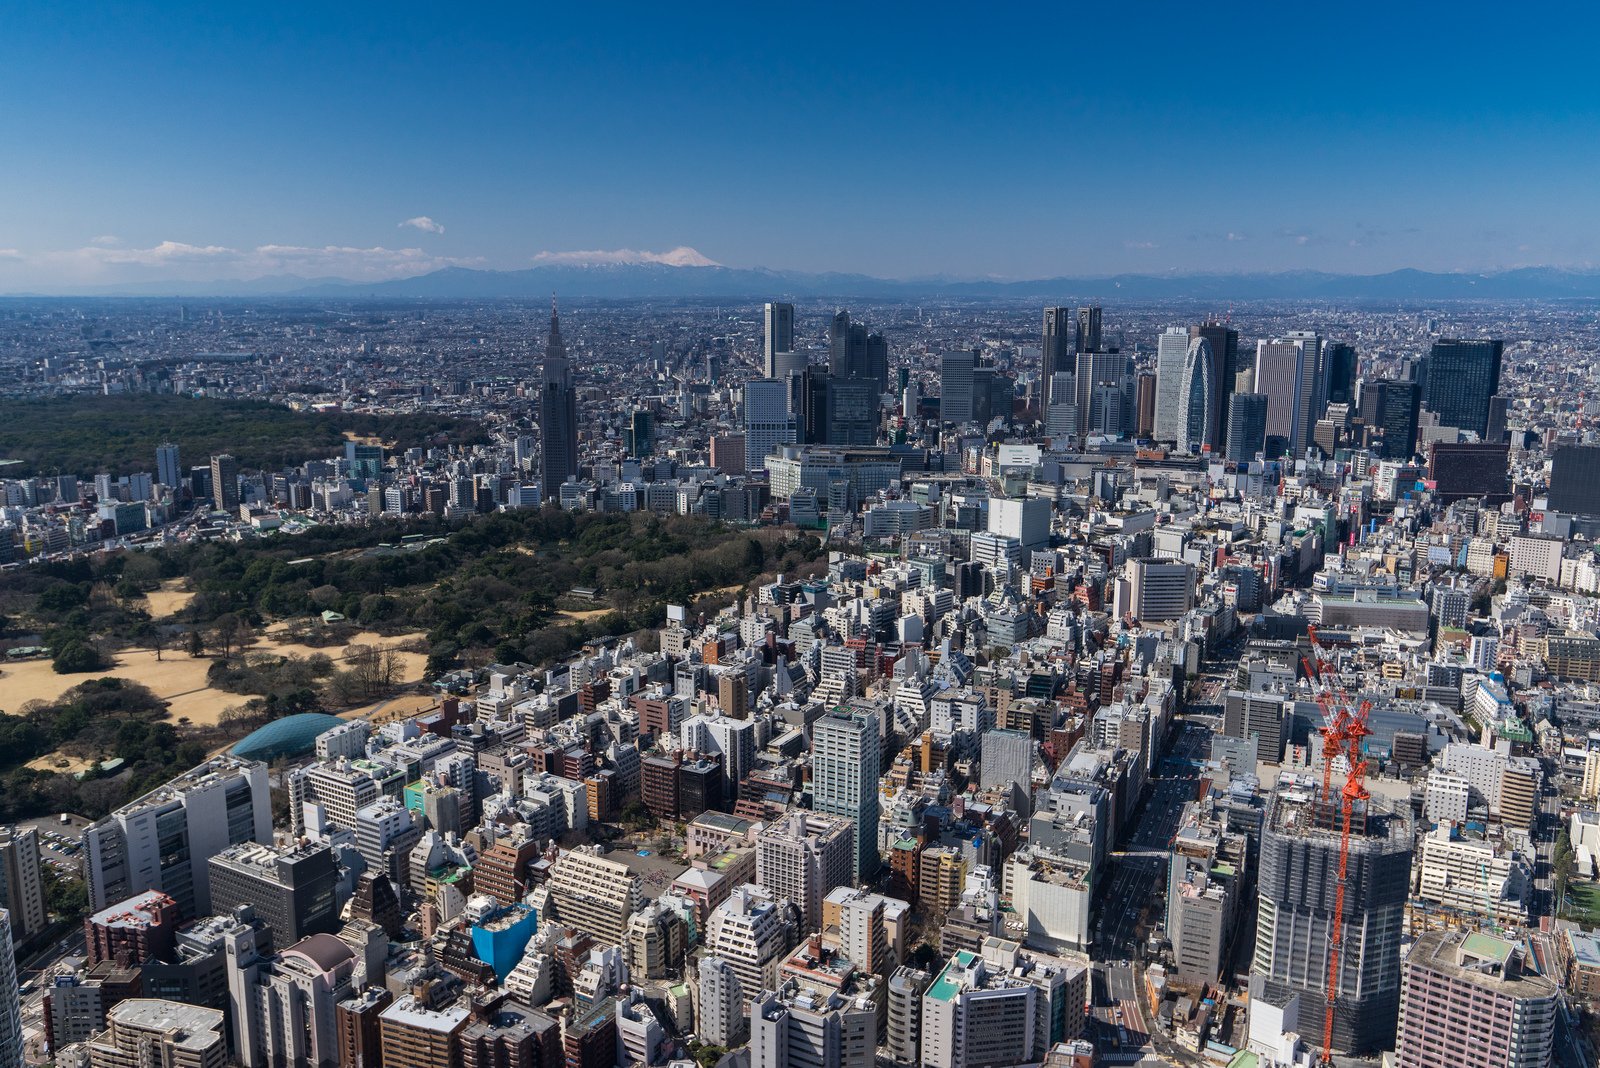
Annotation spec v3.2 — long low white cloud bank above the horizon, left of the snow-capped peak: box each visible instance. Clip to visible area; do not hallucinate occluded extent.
[36,241,483,281]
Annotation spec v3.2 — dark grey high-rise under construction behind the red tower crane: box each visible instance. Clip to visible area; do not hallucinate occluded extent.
[1251,787,1411,1054]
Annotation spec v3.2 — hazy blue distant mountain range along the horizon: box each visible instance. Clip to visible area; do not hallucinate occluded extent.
[12,264,1600,302]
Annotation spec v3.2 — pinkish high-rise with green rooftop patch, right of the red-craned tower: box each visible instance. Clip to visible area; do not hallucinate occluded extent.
[1394,931,1560,1068]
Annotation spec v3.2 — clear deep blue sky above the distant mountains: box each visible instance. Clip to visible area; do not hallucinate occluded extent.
[0,2,1600,291]
